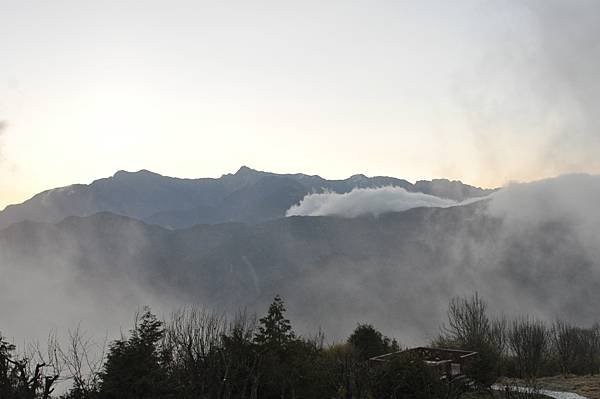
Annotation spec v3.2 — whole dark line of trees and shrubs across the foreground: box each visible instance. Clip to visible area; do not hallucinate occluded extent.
[0,295,600,399]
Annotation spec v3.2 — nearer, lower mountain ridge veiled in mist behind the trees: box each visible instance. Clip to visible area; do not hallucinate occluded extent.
[0,189,600,343]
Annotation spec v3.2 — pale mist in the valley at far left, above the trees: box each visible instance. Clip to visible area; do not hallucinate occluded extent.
[0,216,181,347]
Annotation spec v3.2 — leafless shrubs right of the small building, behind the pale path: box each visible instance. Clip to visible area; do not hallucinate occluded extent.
[432,294,600,385]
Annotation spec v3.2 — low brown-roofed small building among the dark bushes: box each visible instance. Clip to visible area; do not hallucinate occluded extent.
[369,347,477,378]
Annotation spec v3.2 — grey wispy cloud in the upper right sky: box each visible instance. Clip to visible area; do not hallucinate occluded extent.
[455,0,600,181]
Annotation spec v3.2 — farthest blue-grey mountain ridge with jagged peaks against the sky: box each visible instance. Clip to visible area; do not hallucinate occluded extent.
[0,167,491,228]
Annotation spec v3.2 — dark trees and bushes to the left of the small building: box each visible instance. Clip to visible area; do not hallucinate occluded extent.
[0,296,442,399]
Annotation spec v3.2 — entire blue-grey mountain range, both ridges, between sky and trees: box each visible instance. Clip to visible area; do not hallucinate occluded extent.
[0,168,600,343]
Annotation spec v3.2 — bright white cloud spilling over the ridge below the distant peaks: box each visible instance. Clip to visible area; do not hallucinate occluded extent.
[286,187,472,218]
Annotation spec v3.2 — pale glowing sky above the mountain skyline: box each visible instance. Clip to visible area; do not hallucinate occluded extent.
[0,0,600,209]
